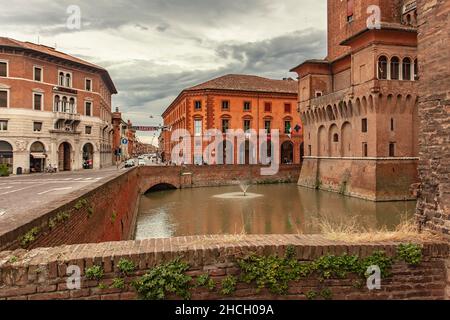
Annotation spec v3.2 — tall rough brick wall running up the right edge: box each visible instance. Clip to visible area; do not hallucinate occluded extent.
[417,0,450,238]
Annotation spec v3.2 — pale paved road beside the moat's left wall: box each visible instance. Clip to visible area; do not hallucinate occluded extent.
[0,167,125,220]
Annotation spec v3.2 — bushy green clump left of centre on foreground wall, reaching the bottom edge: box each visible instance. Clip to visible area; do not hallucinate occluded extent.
[133,259,192,300]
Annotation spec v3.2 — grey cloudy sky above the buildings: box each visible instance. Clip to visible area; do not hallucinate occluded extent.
[0,0,326,143]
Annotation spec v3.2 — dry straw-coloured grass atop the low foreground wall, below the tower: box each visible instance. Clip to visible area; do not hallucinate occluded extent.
[319,219,441,243]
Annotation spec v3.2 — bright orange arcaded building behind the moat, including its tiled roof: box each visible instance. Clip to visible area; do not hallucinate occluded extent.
[159,75,302,164]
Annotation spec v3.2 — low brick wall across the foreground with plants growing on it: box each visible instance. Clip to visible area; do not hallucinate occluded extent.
[0,236,449,300]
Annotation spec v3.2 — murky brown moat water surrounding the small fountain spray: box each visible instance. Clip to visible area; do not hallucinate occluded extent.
[136,184,416,239]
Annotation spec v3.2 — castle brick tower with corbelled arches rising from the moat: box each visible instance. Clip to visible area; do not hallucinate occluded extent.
[292,0,419,201]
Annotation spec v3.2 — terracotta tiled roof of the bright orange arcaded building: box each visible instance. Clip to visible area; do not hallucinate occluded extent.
[185,74,298,94]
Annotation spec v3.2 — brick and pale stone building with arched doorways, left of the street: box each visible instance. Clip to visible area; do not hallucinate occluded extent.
[0,38,117,173]
